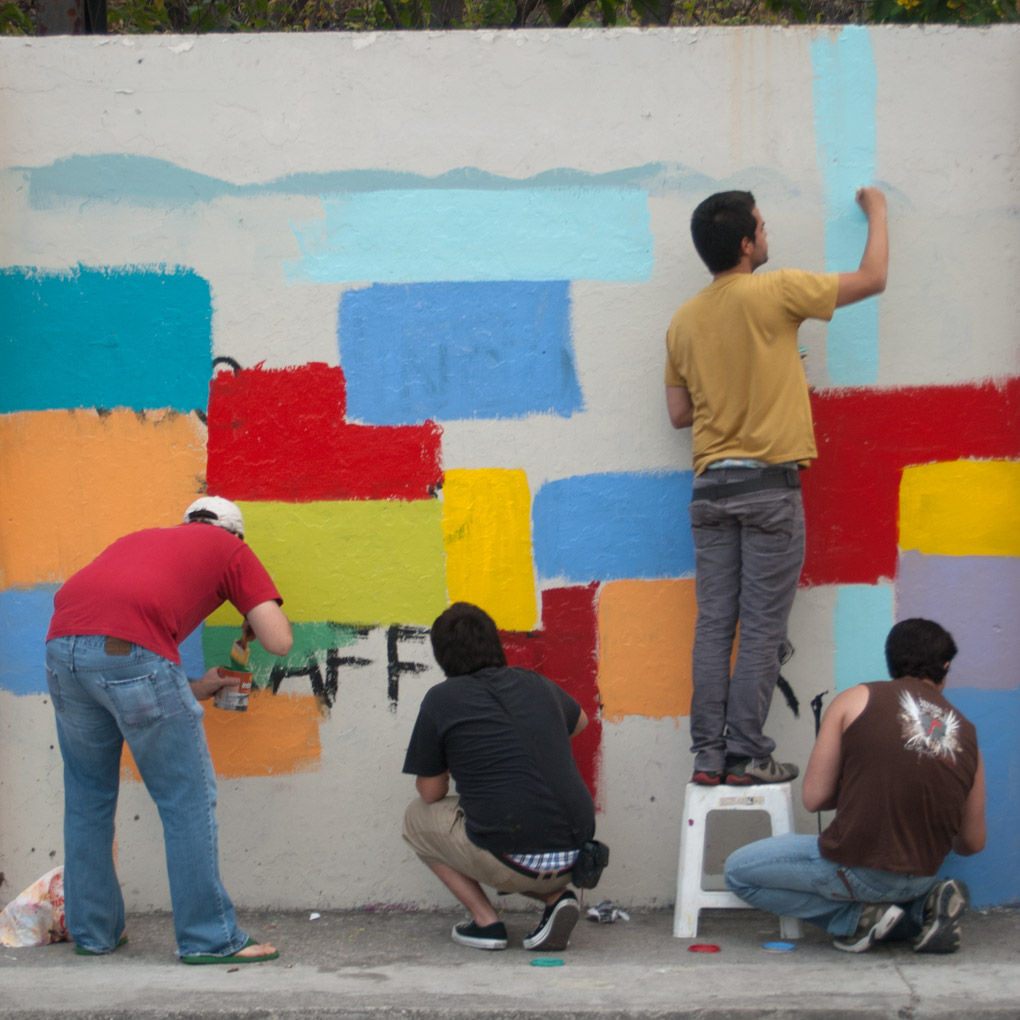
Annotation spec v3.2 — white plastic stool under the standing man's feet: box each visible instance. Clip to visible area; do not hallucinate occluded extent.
[673,782,804,938]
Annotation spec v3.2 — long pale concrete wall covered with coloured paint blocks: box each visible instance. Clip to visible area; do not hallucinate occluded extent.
[0,27,1020,909]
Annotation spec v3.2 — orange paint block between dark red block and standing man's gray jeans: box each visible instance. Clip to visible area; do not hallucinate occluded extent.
[599,579,698,722]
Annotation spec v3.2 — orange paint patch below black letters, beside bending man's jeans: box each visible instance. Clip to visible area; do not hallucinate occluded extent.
[120,690,322,781]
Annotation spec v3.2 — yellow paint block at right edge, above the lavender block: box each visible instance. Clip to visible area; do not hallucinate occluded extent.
[900,460,1020,556]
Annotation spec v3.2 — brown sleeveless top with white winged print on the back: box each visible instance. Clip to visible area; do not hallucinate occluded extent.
[818,679,977,875]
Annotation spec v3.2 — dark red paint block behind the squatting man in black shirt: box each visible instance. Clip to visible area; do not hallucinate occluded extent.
[501,584,602,806]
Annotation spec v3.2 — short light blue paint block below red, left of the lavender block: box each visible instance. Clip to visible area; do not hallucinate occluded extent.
[833,584,893,692]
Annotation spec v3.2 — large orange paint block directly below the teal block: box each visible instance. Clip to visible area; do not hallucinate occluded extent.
[0,409,206,591]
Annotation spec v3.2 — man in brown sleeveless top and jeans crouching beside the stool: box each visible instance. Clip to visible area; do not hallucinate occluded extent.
[725,619,985,953]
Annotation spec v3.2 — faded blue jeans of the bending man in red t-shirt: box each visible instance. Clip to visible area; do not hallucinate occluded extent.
[46,635,248,956]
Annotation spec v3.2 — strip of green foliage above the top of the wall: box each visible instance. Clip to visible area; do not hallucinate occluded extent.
[0,0,1020,35]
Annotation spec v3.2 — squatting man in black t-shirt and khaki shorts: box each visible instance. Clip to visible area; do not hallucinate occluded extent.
[404,602,595,950]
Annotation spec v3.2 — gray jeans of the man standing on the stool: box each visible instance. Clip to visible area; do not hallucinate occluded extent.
[690,468,804,771]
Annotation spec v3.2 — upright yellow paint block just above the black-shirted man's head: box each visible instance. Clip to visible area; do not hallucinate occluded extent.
[443,468,539,630]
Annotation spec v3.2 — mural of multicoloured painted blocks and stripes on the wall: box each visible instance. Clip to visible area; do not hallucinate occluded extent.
[0,23,1020,903]
